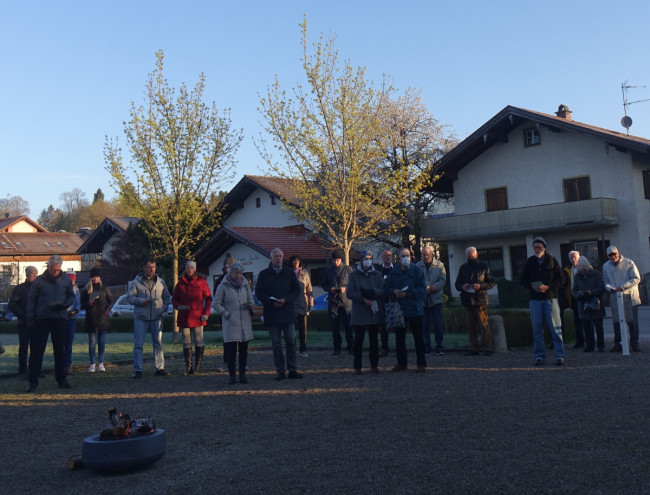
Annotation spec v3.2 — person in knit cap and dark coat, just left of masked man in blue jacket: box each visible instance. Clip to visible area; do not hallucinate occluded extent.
[347,251,384,375]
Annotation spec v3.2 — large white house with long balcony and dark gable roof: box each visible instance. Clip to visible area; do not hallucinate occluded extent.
[423,105,650,295]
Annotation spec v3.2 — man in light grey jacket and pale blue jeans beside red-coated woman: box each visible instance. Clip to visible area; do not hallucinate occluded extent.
[126,258,171,379]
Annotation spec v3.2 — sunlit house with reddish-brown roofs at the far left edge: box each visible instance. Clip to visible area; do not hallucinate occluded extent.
[0,215,82,285]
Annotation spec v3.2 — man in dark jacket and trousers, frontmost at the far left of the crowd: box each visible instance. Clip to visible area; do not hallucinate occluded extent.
[26,255,74,392]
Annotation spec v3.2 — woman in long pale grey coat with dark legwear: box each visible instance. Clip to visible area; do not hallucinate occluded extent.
[212,262,253,385]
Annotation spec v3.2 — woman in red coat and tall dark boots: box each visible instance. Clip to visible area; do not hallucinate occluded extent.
[172,261,212,375]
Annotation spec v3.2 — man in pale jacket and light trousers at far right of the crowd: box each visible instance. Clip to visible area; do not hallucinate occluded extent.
[603,246,641,352]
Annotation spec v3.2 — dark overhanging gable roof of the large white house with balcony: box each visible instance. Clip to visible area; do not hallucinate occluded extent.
[433,105,650,192]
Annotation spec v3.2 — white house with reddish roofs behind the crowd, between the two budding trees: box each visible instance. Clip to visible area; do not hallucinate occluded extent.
[195,175,330,294]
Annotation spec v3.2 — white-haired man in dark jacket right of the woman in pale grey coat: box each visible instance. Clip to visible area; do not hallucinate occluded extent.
[255,248,302,380]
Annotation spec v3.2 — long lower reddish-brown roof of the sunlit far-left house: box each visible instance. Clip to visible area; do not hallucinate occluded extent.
[0,232,83,256]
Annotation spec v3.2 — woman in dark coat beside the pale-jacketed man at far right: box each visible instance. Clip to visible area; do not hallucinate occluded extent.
[572,256,605,352]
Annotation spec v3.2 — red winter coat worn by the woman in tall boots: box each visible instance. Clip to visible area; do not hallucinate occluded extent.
[172,275,212,328]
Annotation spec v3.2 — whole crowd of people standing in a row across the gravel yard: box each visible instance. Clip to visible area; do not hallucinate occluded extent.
[9,237,641,392]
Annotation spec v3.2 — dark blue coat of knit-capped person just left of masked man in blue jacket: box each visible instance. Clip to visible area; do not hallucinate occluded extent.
[346,267,384,326]
